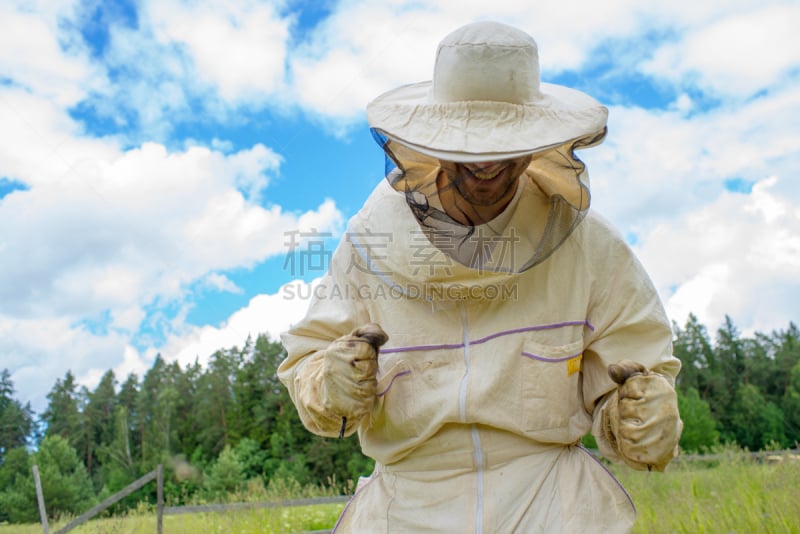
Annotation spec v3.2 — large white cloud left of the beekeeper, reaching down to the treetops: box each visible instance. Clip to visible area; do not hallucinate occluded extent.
[0,82,342,411]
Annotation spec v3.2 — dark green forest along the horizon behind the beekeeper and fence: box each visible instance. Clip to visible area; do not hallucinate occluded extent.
[0,316,800,524]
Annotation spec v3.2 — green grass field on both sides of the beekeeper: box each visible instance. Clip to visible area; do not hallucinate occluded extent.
[0,452,800,534]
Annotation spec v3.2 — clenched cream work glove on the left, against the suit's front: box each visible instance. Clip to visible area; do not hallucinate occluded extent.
[321,323,389,428]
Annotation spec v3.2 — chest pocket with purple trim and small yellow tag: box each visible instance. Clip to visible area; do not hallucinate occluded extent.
[518,340,583,432]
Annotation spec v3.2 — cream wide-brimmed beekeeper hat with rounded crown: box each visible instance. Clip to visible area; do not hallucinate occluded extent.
[367,22,608,162]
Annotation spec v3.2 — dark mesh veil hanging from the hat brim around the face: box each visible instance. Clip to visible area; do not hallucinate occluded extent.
[373,130,605,273]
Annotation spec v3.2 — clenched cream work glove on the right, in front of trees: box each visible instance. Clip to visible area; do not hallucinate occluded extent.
[602,360,683,471]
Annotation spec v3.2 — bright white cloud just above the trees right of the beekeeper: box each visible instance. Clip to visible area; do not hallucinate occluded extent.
[637,177,800,334]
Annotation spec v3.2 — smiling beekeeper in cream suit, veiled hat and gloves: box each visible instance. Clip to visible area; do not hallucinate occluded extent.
[278,22,682,533]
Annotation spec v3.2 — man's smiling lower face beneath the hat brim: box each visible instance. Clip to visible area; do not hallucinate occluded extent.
[441,156,531,207]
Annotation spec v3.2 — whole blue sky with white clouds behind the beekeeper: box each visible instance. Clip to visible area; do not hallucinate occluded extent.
[0,0,800,411]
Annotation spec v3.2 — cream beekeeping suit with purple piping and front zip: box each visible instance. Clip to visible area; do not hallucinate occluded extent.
[278,170,680,534]
